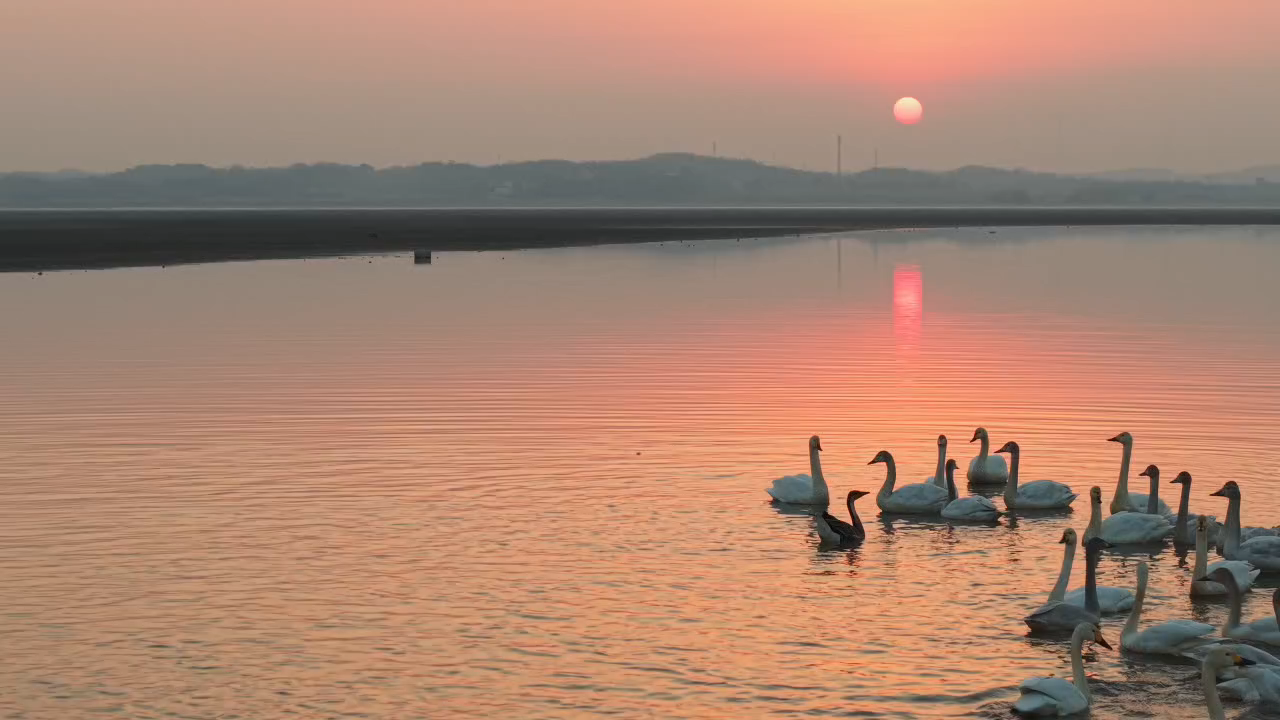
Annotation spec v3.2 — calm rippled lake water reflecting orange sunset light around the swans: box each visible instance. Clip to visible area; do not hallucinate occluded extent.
[0,228,1280,719]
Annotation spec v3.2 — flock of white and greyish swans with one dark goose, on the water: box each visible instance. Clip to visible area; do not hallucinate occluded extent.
[767,428,1280,720]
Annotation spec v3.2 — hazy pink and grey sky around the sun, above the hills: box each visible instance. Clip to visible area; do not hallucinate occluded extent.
[0,0,1280,170]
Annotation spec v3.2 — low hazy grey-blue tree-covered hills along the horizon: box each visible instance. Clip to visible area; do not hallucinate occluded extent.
[0,154,1280,209]
